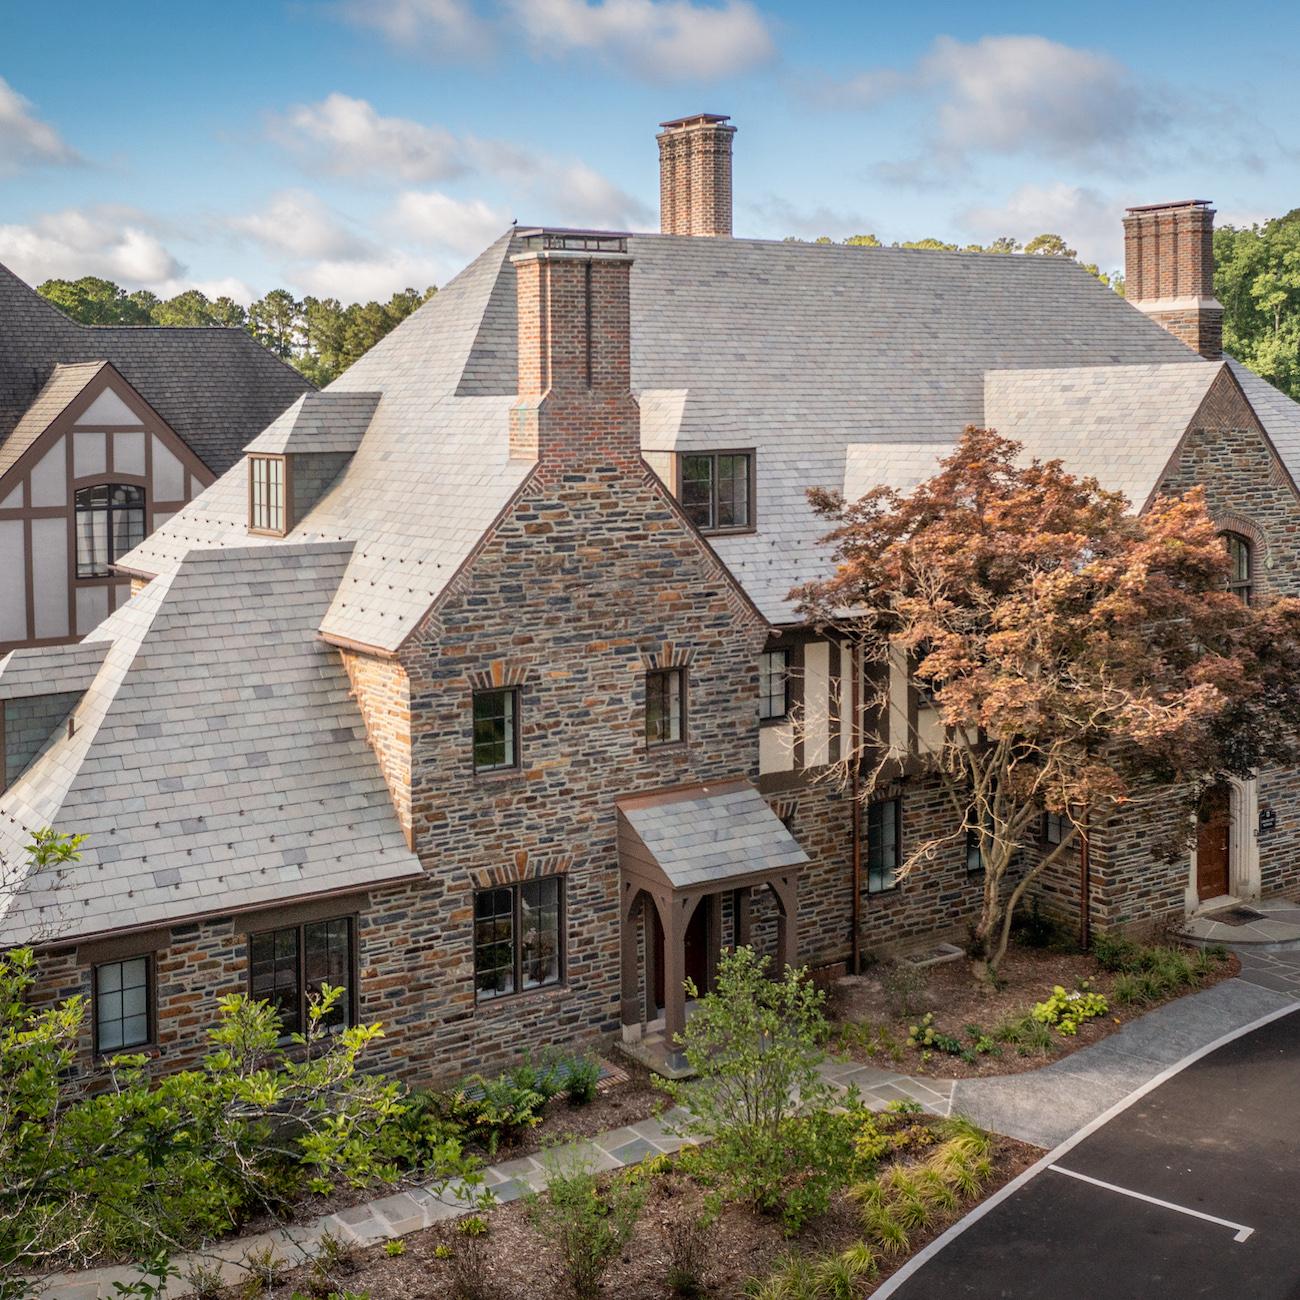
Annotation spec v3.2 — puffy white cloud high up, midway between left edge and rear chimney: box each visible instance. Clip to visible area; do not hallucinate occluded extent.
[273,92,467,183]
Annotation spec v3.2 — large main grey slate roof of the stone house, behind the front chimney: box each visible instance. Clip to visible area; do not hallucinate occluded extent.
[125,233,1248,650]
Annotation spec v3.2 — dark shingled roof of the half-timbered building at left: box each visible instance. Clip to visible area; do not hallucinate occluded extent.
[0,257,311,475]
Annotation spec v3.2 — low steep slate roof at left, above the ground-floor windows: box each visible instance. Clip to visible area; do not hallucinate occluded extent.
[0,545,421,946]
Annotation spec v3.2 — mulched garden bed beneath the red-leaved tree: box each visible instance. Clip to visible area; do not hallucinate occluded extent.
[831,944,1242,1079]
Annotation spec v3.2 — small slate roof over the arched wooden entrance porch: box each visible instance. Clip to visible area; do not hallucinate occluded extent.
[618,781,809,889]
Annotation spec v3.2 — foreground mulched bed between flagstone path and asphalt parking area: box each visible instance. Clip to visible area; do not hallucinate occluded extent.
[233,1138,1041,1300]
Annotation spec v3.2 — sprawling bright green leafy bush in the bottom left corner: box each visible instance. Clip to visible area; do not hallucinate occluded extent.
[0,950,478,1278]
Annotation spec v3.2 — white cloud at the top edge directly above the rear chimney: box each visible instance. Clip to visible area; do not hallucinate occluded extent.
[507,0,776,82]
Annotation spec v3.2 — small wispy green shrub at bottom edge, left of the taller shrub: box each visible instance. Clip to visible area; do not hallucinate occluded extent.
[528,1154,646,1300]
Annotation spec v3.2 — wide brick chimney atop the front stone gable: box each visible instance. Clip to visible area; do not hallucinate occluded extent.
[510,230,641,468]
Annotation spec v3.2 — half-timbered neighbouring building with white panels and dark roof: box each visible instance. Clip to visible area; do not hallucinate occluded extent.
[0,267,311,654]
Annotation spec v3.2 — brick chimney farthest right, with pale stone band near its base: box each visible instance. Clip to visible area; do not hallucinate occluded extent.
[1125,199,1223,361]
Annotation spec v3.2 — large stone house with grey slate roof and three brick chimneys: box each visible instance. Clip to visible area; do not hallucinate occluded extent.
[0,114,1300,1079]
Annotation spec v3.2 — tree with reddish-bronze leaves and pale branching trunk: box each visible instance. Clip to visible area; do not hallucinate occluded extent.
[797,429,1300,975]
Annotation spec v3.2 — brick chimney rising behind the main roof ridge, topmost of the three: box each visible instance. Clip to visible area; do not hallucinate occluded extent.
[658,113,736,235]
